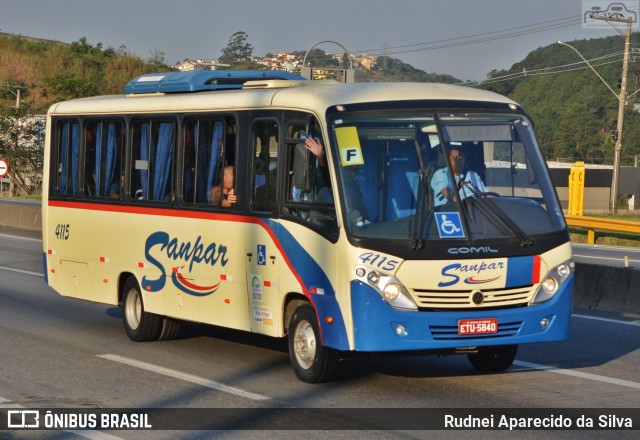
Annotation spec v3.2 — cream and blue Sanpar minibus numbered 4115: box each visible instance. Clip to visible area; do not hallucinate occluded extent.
[42,71,574,383]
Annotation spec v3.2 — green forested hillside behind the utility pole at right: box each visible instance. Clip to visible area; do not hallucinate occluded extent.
[481,34,640,165]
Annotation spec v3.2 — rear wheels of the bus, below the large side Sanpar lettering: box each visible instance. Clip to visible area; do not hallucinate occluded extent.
[122,277,164,342]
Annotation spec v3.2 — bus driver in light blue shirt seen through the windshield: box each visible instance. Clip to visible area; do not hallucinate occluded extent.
[431,143,487,206]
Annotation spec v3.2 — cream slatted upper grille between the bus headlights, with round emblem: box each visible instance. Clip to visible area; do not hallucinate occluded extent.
[410,286,535,309]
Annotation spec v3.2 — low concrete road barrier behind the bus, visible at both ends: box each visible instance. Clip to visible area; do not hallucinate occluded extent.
[0,199,640,313]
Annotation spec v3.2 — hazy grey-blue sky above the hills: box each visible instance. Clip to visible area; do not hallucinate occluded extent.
[0,0,640,81]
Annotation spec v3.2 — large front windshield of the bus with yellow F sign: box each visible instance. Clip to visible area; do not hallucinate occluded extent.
[330,111,565,241]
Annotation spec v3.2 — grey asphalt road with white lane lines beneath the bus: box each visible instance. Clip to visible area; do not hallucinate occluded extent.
[0,234,640,440]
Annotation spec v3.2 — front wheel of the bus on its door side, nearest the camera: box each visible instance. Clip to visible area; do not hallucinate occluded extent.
[288,304,339,383]
